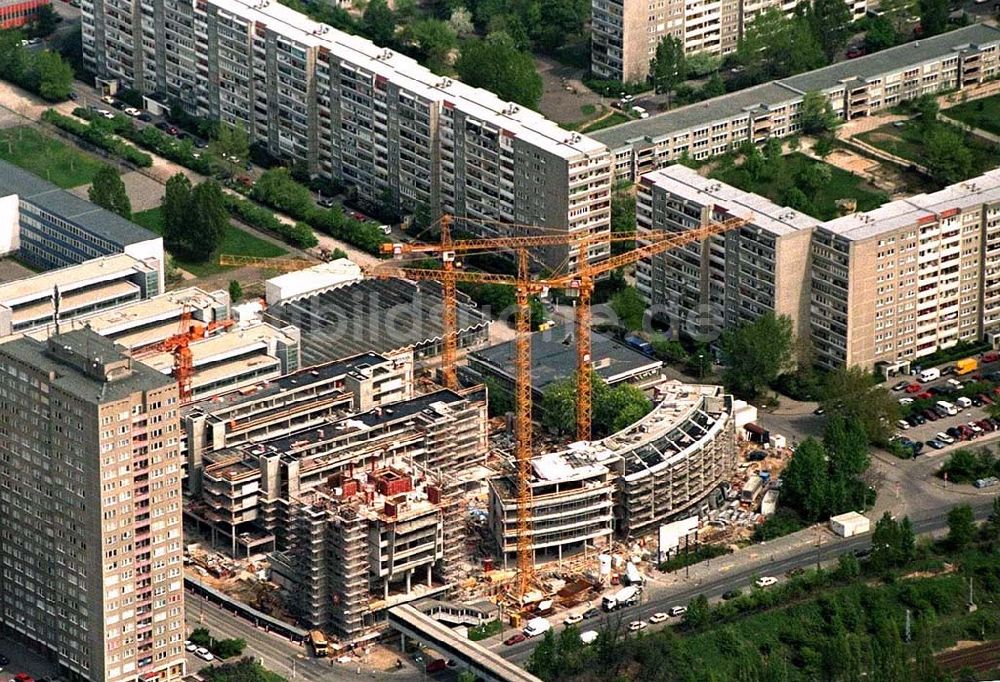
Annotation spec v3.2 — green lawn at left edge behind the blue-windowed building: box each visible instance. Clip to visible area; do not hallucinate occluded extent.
[0,126,101,189]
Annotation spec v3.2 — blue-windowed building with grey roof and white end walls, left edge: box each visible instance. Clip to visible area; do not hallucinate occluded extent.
[0,161,164,284]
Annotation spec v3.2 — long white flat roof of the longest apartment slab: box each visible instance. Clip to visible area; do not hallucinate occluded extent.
[210,0,607,160]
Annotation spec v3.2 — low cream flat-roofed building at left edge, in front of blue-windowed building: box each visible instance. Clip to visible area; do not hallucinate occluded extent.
[0,254,159,339]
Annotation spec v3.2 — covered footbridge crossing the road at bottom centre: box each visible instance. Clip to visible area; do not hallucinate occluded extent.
[389,604,541,682]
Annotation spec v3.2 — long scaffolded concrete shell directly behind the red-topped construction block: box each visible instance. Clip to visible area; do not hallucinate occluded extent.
[187,390,488,564]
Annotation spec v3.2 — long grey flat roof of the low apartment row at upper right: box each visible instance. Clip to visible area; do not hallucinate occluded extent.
[591,24,1000,150]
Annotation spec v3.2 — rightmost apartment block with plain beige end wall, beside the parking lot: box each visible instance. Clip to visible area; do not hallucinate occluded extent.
[810,171,1000,368]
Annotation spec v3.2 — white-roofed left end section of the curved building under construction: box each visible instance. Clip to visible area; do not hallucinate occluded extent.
[489,452,615,568]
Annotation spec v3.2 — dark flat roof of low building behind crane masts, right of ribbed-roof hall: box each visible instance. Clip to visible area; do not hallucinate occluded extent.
[469,324,663,391]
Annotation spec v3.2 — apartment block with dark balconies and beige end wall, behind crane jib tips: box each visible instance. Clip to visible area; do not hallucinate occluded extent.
[636,164,819,341]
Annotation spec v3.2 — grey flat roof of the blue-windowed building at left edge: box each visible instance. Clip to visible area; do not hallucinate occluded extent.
[0,161,160,246]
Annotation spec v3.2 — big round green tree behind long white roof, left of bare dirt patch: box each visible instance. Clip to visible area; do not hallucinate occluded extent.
[455,33,542,108]
